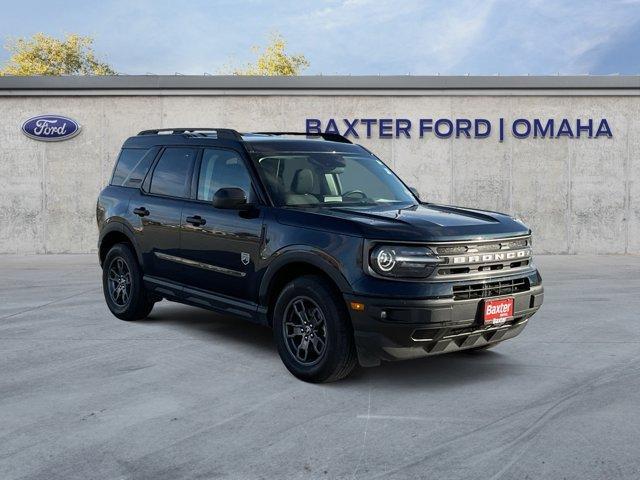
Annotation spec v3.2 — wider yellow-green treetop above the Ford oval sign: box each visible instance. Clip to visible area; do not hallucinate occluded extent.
[0,33,116,75]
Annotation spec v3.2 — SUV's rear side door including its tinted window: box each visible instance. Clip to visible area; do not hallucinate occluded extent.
[129,147,197,281]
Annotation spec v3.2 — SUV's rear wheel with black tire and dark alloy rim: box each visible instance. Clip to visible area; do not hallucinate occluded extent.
[102,243,155,320]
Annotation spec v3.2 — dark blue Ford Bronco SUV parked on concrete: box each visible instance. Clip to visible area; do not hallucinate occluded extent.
[97,128,543,382]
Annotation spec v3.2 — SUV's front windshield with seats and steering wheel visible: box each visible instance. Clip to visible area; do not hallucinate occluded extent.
[252,152,417,207]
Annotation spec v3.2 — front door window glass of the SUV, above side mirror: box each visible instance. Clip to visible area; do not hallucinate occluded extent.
[198,148,251,200]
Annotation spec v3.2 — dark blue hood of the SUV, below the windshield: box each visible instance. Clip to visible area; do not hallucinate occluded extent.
[279,204,530,241]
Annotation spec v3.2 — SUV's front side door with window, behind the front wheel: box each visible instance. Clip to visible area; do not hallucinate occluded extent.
[180,148,263,302]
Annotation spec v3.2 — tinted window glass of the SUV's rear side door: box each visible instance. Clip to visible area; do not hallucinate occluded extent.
[149,148,195,197]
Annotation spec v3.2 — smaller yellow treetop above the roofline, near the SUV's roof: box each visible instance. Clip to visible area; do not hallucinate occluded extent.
[231,33,309,76]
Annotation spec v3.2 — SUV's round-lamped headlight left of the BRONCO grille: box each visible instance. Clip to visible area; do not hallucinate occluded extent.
[369,245,439,278]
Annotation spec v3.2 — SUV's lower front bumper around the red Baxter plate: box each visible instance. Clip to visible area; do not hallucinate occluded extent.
[345,284,544,366]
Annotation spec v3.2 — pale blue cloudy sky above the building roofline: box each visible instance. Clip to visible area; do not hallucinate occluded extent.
[0,0,640,75]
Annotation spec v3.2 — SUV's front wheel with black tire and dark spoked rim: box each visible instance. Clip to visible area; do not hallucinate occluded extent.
[273,275,357,383]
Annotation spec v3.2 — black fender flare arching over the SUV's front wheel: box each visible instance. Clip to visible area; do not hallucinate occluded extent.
[258,245,353,306]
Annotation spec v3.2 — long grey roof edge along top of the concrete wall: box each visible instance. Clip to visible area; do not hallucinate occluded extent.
[0,75,640,96]
